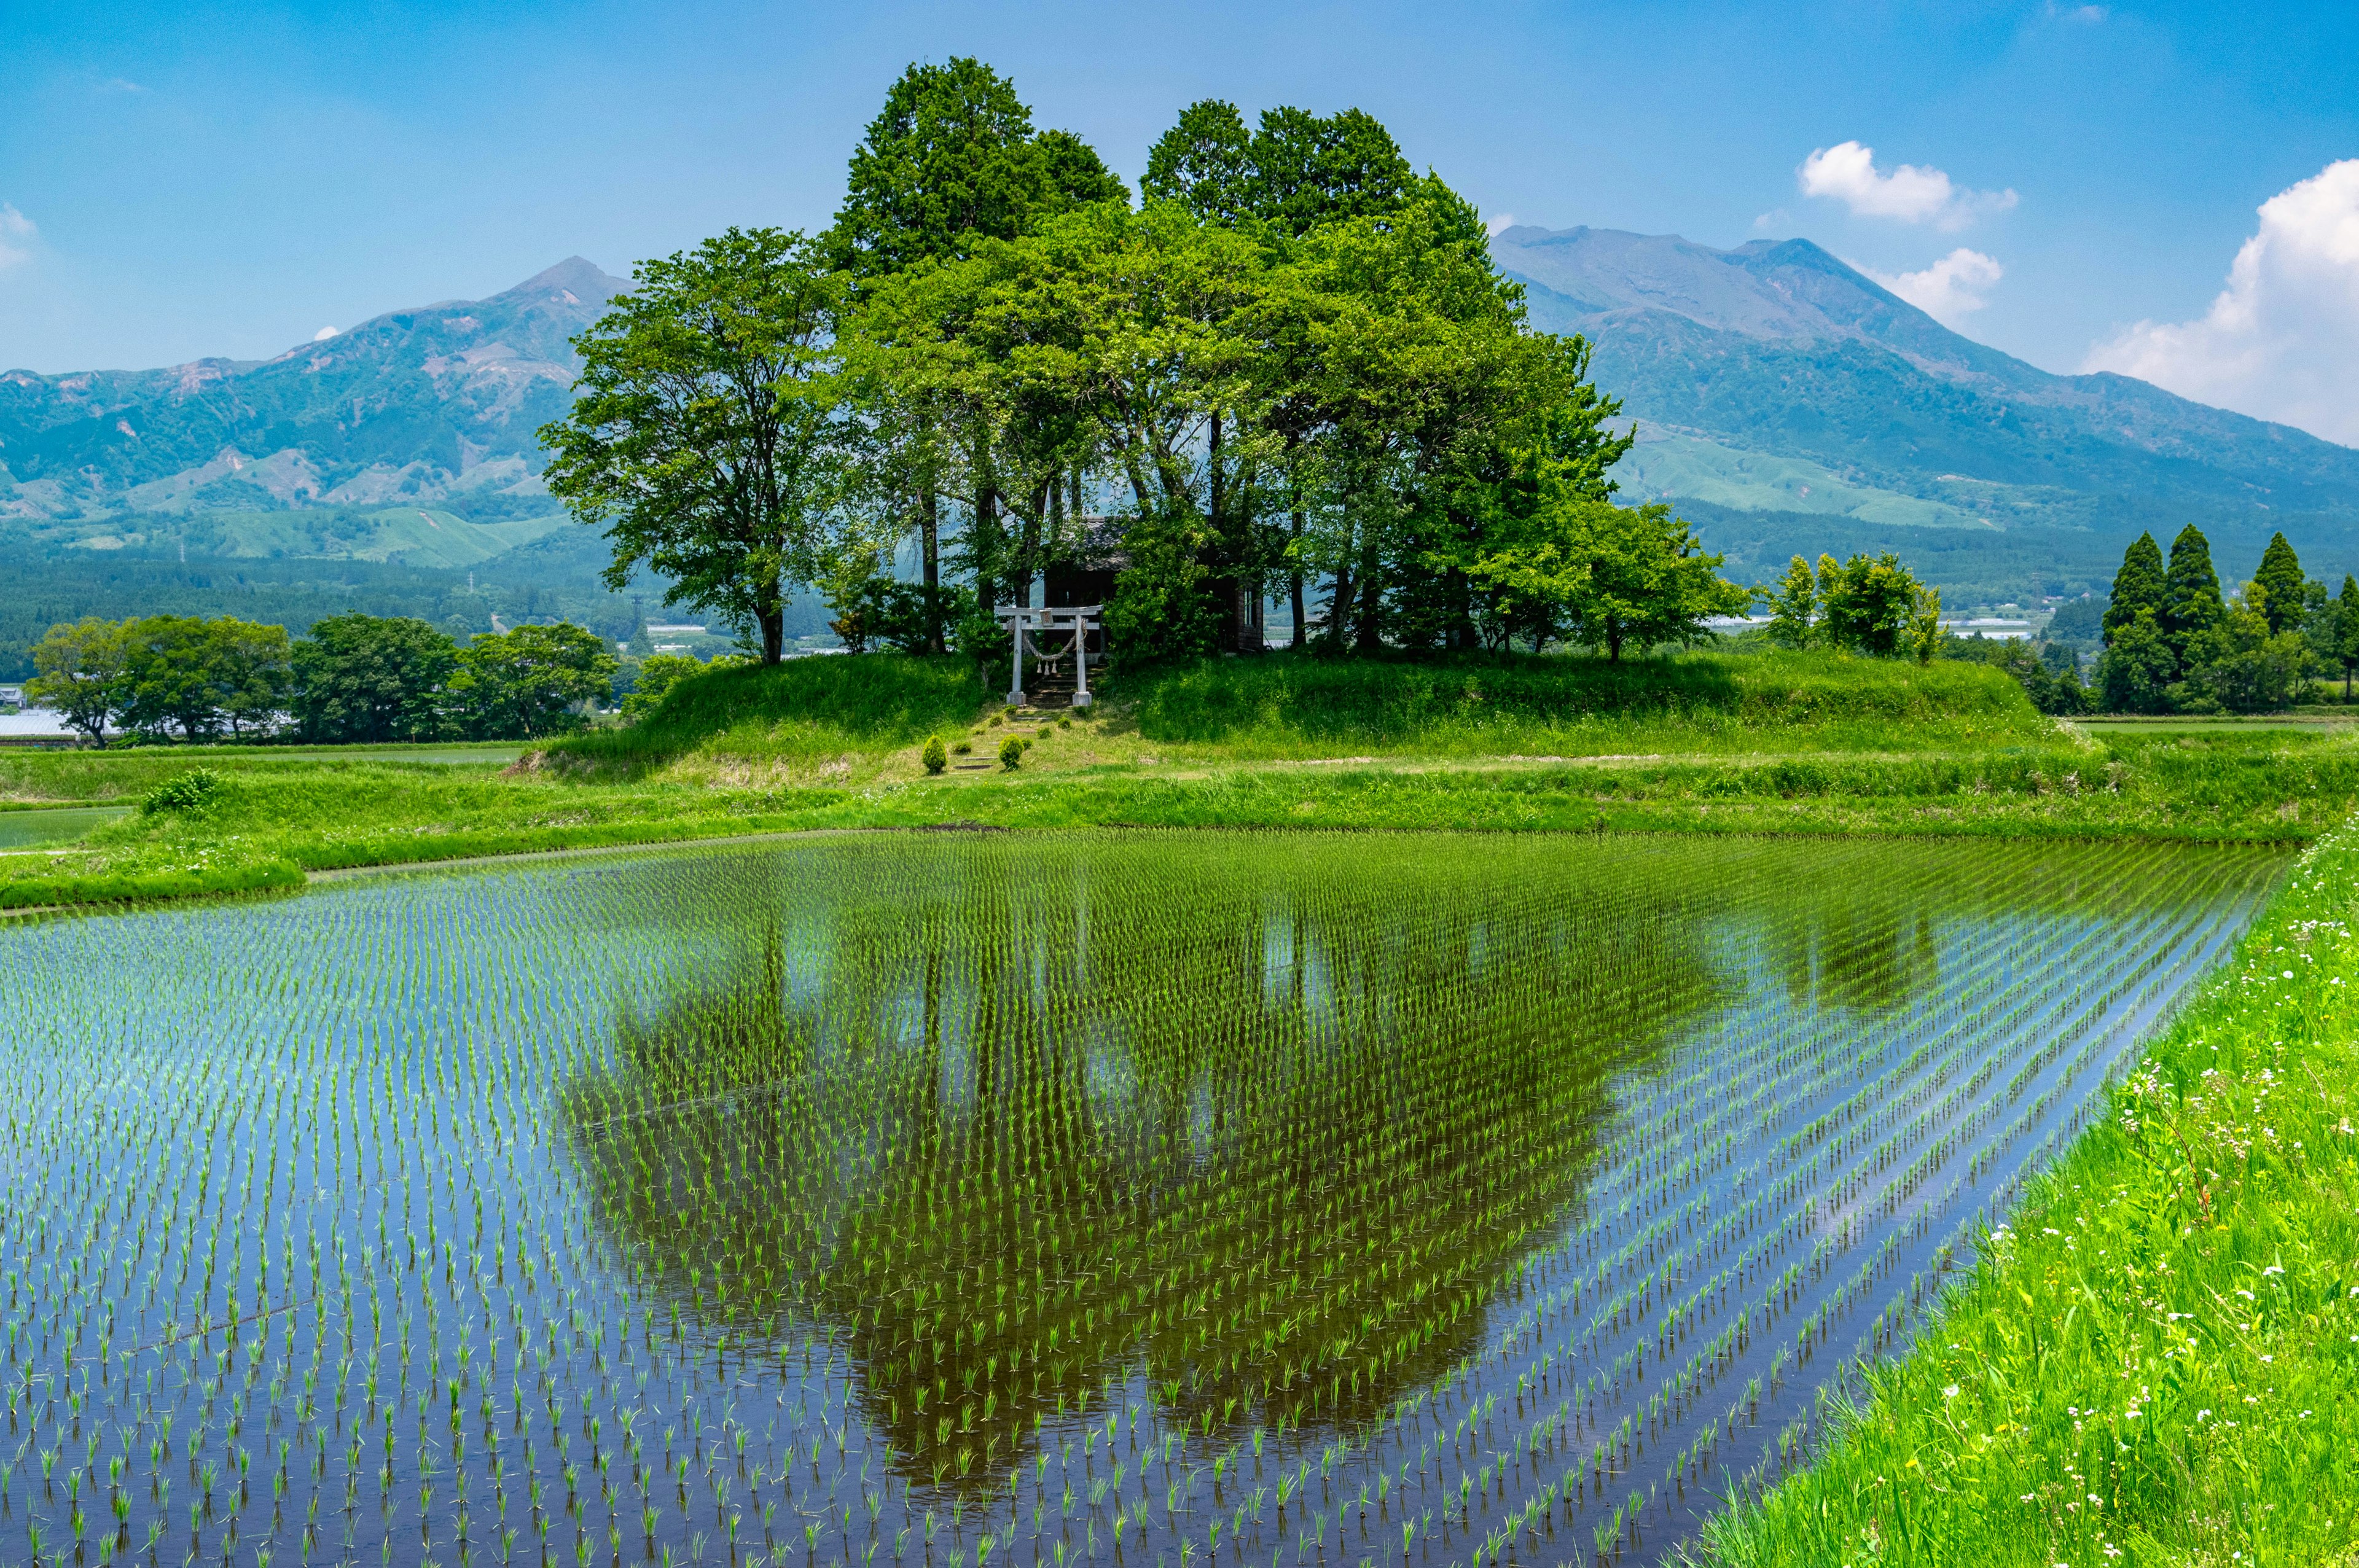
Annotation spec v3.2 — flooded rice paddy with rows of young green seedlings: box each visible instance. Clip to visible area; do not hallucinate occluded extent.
[0,832,2283,1568]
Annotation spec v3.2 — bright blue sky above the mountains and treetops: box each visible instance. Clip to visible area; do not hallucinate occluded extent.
[0,0,2359,439]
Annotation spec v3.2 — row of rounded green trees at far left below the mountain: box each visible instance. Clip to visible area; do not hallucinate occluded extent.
[26,615,616,745]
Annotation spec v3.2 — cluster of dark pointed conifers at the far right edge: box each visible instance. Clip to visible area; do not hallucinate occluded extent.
[2087,526,2359,714]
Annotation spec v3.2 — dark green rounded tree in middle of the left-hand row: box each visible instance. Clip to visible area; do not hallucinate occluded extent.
[290,615,458,745]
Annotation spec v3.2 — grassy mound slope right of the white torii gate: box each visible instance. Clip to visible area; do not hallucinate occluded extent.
[1118,653,2057,757]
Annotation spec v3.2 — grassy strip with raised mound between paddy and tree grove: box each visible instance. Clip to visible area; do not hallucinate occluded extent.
[0,655,2359,908]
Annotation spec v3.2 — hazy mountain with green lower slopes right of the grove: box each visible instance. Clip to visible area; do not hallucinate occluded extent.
[1493,227,2359,592]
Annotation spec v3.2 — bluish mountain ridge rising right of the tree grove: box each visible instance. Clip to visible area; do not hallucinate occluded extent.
[1491,227,2359,547]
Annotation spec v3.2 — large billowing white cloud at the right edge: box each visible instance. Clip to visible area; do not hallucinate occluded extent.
[2081,158,2359,446]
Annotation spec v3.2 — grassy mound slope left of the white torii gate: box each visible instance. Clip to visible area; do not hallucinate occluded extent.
[550,653,986,769]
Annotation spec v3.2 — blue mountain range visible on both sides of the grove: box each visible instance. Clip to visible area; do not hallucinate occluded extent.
[0,227,2359,622]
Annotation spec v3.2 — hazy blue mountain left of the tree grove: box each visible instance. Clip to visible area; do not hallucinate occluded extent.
[0,257,623,526]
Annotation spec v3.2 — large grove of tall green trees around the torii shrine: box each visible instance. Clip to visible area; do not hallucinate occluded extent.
[542,59,1755,663]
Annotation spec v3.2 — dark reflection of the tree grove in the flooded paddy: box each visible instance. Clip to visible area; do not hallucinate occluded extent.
[568,840,1718,1486]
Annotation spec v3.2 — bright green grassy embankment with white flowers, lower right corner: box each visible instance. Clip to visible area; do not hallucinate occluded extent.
[1705,830,2359,1568]
